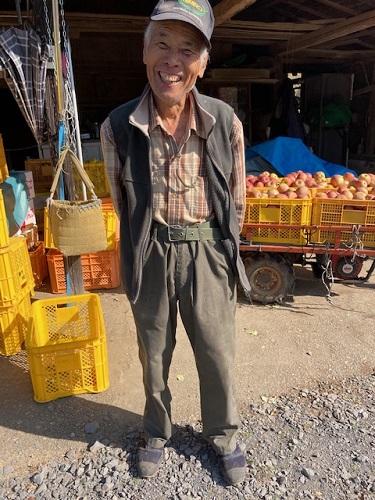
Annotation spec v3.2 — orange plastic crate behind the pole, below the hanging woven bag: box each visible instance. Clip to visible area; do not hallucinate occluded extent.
[47,244,120,293]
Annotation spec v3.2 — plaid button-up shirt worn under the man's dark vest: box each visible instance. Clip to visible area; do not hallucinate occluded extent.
[101,87,245,228]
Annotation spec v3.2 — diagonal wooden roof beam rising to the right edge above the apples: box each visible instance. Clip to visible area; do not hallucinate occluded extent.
[272,10,375,55]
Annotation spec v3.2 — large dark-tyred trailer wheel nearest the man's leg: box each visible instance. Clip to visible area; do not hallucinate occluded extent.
[244,252,295,304]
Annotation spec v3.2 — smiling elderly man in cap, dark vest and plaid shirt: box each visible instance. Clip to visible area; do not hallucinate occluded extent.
[101,0,249,484]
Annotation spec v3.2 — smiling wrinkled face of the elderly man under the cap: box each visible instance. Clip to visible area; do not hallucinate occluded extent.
[143,21,208,106]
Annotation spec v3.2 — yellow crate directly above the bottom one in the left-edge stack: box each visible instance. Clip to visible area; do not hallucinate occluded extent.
[0,237,34,310]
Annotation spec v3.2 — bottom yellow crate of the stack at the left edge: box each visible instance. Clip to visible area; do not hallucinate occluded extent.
[0,293,31,356]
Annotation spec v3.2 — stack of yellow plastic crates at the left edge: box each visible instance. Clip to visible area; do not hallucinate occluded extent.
[0,191,34,356]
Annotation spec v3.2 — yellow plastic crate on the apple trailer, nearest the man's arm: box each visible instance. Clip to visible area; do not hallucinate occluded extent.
[243,198,311,245]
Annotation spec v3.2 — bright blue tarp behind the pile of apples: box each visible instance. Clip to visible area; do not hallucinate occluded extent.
[246,137,357,177]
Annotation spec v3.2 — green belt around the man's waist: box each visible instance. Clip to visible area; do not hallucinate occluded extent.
[151,221,223,243]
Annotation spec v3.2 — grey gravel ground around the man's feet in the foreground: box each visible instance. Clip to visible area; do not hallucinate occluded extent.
[0,373,375,500]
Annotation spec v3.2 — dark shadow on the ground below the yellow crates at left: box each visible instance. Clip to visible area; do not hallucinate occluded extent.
[0,351,141,443]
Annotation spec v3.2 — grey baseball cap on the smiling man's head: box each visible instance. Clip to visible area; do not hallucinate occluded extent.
[151,0,215,49]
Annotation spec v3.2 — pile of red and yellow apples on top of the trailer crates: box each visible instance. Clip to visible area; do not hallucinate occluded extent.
[246,170,375,200]
